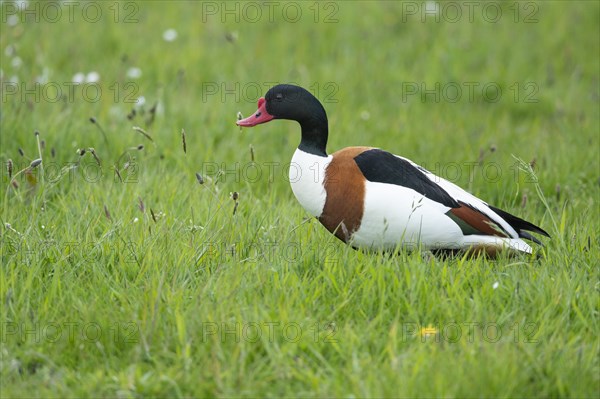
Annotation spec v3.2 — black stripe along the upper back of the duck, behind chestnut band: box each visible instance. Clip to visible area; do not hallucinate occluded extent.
[354,149,460,208]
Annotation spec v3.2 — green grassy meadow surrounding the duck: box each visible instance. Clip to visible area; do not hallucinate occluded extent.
[0,1,600,397]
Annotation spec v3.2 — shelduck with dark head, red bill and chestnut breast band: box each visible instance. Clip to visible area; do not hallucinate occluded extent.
[236,84,550,257]
